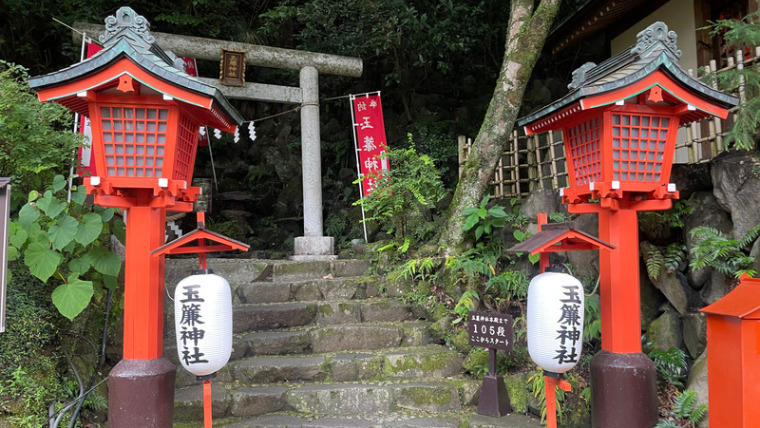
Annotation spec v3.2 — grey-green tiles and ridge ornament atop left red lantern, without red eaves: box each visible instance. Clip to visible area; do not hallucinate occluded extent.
[29,6,243,125]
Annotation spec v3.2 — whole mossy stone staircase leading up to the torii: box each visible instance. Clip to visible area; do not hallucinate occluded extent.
[165,259,541,428]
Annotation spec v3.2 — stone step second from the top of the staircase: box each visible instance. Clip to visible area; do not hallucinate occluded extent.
[231,277,381,304]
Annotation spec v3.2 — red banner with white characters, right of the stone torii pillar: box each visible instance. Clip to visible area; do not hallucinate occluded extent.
[351,93,388,196]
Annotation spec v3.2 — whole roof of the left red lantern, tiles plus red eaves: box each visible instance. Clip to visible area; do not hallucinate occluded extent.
[29,6,243,132]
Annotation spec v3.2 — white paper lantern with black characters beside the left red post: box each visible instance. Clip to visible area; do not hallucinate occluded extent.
[174,269,232,377]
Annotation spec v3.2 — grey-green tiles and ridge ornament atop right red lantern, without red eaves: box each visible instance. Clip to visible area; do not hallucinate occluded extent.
[517,21,739,126]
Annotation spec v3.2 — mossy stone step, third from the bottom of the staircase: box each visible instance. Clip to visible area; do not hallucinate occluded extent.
[177,345,463,386]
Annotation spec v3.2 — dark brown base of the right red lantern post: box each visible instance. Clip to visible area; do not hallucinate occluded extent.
[591,350,659,428]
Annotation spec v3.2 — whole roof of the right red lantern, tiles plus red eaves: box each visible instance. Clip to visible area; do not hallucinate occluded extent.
[517,21,739,135]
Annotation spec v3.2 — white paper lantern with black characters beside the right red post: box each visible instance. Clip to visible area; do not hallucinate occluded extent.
[527,272,584,374]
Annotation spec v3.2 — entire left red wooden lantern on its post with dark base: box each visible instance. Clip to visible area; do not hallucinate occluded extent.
[30,7,242,428]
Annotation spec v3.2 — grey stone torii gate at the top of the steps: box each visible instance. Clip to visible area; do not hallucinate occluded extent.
[73,23,363,260]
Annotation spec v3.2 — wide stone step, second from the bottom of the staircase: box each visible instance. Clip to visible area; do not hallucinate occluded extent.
[174,379,479,422]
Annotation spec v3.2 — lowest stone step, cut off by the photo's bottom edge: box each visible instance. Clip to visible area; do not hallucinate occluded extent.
[214,408,543,428]
